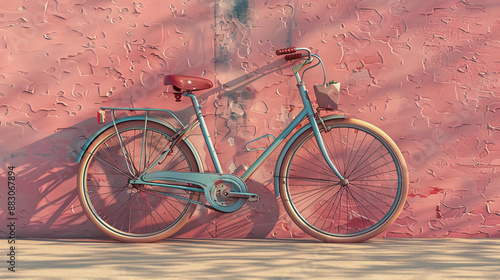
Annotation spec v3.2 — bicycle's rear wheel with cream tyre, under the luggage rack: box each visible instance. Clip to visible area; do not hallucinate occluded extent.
[78,121,201,242]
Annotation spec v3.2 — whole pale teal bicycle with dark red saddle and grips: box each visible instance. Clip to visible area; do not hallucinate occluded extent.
[77,48,408,242]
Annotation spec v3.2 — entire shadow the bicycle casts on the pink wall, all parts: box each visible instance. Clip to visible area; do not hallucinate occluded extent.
[3,59,304,241]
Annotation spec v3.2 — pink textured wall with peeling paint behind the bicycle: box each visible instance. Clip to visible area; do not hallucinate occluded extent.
[0,0,500,238]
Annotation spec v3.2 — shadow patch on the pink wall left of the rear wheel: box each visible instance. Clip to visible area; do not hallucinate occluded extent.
[2,127,90,238]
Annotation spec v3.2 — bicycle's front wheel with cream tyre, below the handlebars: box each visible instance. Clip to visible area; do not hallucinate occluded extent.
[279,119,408,242]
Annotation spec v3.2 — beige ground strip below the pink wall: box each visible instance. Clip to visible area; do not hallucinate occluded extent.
[0,239,500,279]
